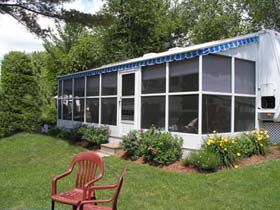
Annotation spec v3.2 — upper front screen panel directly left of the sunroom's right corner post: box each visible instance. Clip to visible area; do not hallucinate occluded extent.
[169,57,199,92]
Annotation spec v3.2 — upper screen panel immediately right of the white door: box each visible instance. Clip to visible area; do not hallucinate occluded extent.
[142,64,166,94]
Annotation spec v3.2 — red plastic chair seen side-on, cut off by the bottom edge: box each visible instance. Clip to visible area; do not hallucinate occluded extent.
[78,167,126,210]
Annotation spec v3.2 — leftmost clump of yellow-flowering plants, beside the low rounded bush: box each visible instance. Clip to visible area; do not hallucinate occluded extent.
[203,134,239,167]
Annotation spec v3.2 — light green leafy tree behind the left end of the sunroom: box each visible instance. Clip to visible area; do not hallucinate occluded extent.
[44,23,106,95]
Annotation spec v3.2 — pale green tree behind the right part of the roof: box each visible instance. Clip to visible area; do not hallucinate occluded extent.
[179,0,248,44]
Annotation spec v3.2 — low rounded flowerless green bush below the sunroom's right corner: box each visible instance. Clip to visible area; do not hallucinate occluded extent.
[183,150,221,171]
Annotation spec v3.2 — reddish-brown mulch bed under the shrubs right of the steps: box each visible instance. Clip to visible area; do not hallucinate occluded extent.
[117,146,280,174]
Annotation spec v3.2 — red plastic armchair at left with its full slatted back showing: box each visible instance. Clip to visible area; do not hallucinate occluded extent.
[51,152,104,210]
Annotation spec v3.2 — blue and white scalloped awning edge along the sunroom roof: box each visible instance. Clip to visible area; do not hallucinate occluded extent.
[58,35,259,80]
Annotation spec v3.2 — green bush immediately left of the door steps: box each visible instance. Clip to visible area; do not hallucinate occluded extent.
[79,126,109,146]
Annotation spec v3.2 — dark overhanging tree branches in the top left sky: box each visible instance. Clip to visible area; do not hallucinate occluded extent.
[0,0,110,36]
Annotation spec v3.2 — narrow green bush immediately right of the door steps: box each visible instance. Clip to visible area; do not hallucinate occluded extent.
[120,130,141,160]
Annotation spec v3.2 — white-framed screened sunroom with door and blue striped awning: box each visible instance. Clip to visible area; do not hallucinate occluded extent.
[57,35,258,149]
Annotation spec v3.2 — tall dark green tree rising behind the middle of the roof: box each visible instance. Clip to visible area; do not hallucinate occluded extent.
[100,0,182,61]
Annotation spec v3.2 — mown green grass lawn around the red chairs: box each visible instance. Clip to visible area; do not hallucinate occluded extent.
[0,133,280,210]
